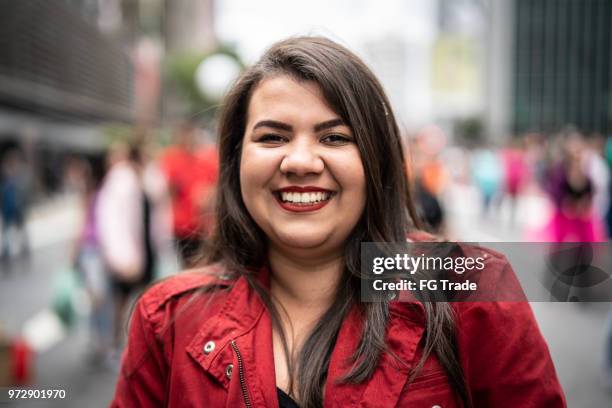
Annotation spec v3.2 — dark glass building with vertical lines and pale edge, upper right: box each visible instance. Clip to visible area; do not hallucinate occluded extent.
[487,0,612,137]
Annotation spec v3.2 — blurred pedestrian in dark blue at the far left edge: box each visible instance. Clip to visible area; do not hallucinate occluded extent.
[0,148,30,263]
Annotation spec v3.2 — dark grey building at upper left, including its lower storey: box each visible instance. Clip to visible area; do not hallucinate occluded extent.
[0,0,134,192]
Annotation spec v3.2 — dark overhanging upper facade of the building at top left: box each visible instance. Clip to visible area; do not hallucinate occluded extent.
[0,0,132,124]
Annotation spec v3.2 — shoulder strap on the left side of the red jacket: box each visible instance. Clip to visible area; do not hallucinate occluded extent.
[140,265,234,316]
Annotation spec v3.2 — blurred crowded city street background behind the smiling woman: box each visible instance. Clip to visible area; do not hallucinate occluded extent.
[0,0,612,408]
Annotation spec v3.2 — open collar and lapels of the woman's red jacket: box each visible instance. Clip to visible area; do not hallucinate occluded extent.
[187,268,425,407]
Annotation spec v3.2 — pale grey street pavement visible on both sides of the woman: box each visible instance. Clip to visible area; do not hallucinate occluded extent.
[0,187,612,408]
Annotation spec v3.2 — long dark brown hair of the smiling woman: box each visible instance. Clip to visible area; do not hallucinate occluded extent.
[208,37,470,407]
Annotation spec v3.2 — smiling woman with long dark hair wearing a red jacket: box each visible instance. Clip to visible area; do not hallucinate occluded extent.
[112,37,565,407]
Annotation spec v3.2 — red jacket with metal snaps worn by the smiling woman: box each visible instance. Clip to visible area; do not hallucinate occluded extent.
[111,259,566,408]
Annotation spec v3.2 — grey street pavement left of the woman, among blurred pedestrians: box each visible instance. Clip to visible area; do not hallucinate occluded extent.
[0,197,118,408]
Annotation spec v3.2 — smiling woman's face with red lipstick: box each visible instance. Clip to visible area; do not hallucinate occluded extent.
[240,75,366,252]
